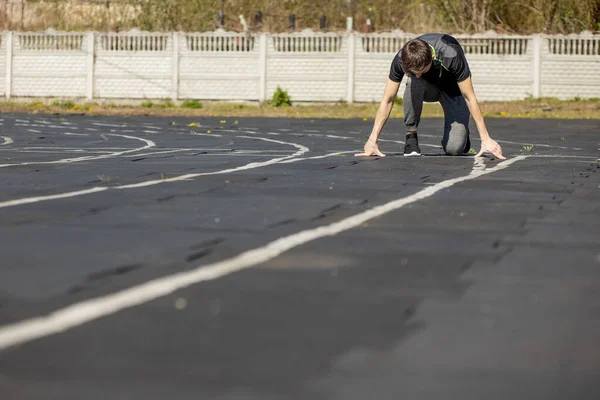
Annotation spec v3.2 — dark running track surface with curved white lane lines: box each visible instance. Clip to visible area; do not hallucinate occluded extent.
[0,115,600,400]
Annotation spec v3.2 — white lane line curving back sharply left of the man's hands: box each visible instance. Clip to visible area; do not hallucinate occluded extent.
[0,136,309,208]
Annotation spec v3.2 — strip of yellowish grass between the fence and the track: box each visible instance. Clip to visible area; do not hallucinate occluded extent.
[0,98,600,121]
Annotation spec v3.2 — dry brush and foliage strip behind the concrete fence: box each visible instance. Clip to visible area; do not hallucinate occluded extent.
[9,0,600,34]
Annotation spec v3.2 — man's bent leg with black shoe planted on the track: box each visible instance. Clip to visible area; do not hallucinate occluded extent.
[403,78,440,156]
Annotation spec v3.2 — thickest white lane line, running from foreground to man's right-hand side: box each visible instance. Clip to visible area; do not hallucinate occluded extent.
[0,156,527,350]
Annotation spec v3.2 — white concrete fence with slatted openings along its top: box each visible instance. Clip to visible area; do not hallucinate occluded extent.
[0,31,600,102]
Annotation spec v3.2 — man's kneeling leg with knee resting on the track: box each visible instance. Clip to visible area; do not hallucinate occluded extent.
[440,92,471,156]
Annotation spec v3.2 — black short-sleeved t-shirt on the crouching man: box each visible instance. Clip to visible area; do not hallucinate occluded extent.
[390,33,471,96]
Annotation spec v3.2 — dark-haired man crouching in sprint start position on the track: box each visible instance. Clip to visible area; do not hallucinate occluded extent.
[356,33,505,159]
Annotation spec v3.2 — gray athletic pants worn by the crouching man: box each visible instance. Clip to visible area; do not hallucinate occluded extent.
[404,78,470,156]
